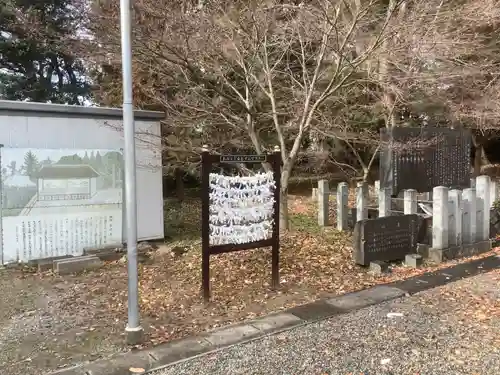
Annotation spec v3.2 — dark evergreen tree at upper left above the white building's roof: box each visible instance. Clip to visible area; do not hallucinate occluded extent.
[0,0,90,104]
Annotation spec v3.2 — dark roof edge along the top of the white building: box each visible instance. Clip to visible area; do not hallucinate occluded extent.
[0,100,165,120]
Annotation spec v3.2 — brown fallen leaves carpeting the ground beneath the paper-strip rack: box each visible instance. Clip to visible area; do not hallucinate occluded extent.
[7,198,500,354]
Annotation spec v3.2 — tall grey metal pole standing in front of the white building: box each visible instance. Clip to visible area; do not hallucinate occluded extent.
[120,0,143,345]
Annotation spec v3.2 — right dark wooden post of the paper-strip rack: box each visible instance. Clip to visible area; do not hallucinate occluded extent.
[271,146,286,289]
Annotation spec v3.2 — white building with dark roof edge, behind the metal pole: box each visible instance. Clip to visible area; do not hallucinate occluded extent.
[0,100,164,264]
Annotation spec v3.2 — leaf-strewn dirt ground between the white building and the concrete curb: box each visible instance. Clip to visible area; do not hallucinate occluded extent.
[0,197,498,375]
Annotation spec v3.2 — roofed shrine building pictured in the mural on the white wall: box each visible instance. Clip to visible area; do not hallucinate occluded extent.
[37,164,100,201]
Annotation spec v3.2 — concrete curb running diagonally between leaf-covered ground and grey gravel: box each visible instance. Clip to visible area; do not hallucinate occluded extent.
[51,255,500,375]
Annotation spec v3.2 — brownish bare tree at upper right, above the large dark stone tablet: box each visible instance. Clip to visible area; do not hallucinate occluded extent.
[390,0,500,173]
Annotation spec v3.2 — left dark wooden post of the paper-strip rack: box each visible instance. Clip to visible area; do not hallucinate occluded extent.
[201,145,211,303]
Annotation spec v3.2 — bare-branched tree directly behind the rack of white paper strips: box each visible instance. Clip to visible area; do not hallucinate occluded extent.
[93,0,410,228]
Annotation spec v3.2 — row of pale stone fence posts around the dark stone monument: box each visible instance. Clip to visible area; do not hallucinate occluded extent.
[315,176,498,249]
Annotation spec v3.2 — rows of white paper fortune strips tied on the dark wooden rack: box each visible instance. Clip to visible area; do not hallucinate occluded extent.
[210,172,275,245]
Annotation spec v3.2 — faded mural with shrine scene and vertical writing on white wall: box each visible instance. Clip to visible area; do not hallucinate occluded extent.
[1,148,123,263]
